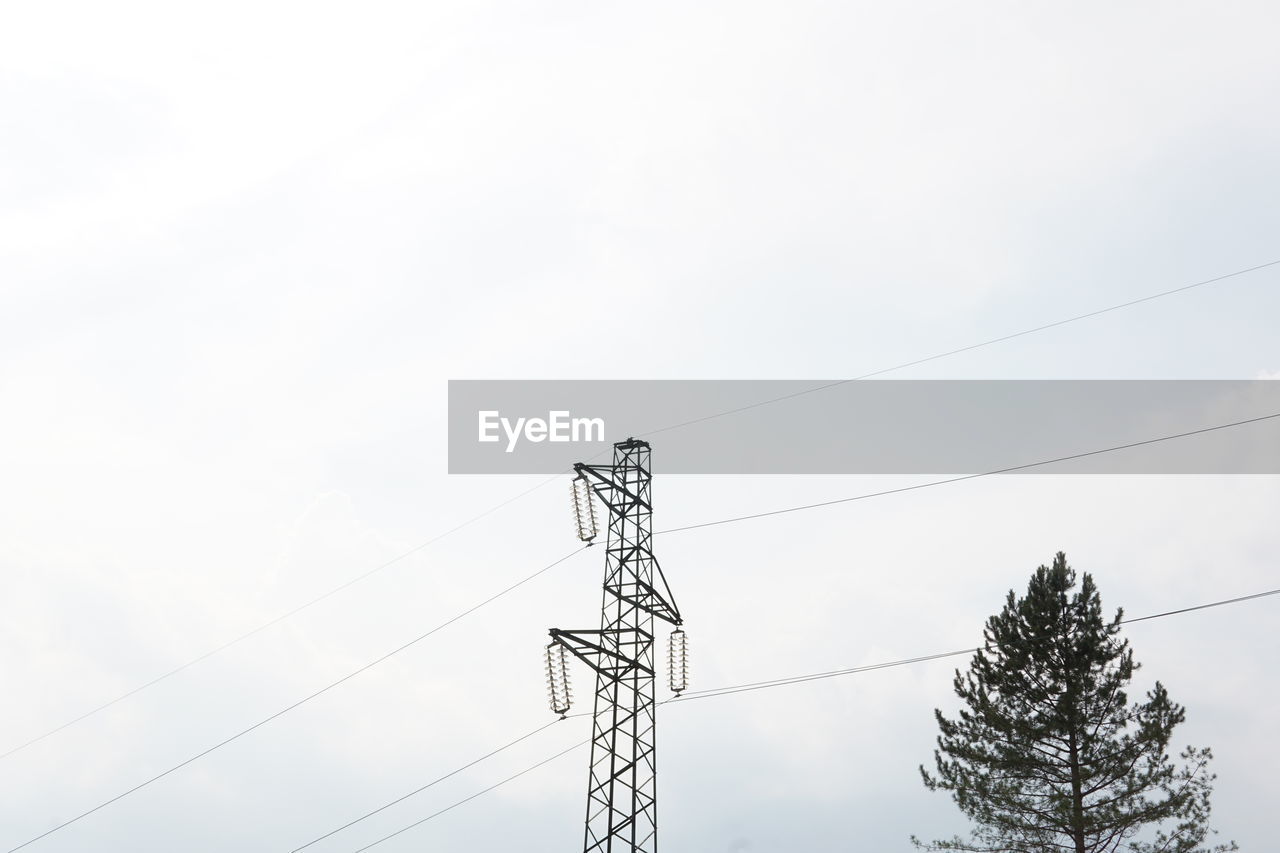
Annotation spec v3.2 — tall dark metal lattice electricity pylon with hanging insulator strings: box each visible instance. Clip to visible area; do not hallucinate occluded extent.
[547,438,687,853]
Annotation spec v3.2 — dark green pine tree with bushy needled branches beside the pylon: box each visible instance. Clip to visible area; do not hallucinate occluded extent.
[911,552,1238,853]
